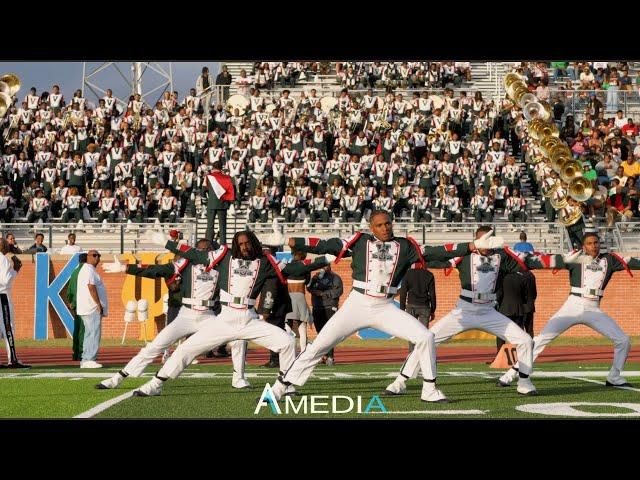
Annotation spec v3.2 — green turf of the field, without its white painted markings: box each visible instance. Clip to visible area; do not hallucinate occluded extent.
[0,362,640,419]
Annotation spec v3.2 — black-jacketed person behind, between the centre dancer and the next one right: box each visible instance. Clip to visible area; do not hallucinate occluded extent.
[399,266,436,351]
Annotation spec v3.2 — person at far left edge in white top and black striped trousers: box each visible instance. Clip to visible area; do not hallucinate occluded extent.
[0,238,30,368]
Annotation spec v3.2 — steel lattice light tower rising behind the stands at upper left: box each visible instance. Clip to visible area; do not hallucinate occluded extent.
[82,62,173,108]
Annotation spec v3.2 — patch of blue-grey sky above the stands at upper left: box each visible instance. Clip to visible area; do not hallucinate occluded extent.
[0,61,218,107]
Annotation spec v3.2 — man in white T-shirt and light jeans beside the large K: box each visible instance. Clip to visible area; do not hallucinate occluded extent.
[76,250,109,368]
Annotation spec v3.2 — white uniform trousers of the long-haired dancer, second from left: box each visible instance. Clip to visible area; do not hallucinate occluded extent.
[157,306,295,378]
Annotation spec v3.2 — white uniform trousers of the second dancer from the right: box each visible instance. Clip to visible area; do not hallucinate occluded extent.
[400,299,533,378]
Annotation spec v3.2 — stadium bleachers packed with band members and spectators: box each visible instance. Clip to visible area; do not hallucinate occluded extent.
[0,62,640,251]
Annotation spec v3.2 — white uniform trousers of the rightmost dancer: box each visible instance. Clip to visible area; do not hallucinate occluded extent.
[516,295,631,383]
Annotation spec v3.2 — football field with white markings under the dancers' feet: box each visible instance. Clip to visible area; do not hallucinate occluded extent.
[0,362,640,420]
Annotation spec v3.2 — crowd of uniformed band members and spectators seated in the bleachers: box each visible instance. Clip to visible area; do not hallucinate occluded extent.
[0,62,640,231]
